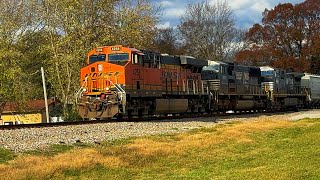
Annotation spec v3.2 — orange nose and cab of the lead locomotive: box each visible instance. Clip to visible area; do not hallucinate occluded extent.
[77,46,143,118]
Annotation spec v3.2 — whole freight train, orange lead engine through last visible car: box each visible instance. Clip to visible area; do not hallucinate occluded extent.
[77,45,320,119]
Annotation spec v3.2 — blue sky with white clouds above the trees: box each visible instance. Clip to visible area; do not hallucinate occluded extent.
[151,0,303,29]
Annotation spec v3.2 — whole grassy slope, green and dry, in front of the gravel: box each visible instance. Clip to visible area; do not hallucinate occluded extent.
[0,118,320,179]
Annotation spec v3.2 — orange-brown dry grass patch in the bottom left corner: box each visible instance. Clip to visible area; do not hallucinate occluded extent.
[0,149,121,179]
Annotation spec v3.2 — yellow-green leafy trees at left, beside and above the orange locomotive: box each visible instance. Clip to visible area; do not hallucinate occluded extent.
[0,0,158,118]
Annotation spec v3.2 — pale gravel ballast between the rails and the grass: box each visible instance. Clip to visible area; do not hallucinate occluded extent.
[0,110,320,152]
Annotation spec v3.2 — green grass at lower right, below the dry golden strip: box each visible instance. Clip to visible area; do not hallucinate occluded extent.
[74,120,320,179]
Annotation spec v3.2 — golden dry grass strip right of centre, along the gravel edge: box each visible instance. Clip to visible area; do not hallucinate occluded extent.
[126,117,295,158]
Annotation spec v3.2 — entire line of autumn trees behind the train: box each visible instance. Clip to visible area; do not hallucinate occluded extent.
[0,0,320,117]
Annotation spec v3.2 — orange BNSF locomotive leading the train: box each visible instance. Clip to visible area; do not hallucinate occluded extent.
[78,45,210,119]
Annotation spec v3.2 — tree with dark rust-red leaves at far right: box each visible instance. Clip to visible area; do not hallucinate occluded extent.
[236,0,320,73]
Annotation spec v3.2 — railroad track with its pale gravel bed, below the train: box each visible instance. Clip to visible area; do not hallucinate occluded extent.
[0,111,312,152]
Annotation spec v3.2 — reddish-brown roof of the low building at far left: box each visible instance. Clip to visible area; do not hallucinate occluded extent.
[3,98,57,112]
